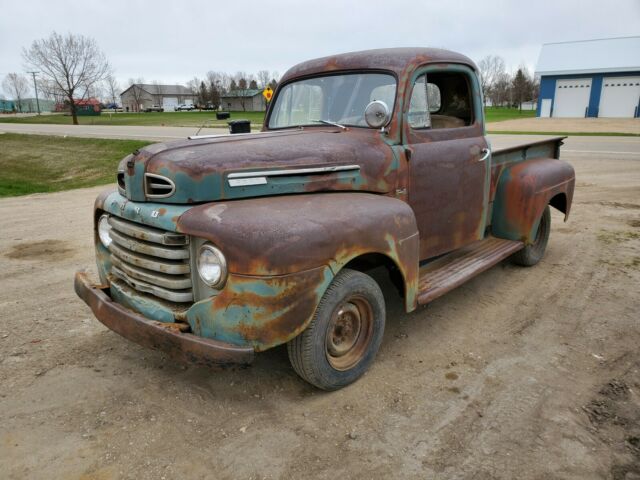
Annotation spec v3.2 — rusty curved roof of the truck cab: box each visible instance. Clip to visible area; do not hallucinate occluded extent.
[280,47,477,83]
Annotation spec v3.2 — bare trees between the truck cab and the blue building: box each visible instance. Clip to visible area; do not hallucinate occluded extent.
[478,55,540,110]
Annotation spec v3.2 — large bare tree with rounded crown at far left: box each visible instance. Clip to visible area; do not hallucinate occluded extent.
[22,32,109,125]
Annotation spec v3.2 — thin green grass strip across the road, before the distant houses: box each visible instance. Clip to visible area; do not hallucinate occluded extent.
[0,111,264,127]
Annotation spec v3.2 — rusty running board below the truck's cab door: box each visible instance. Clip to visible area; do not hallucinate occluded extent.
[418,237,524,305]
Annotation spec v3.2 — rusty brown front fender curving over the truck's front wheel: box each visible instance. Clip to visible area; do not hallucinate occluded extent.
[177,192,419,316]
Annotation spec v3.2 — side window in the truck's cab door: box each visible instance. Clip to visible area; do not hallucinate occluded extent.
[407,72,473,129]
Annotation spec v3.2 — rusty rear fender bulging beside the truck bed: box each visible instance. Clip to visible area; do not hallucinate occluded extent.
[491,158,575,244]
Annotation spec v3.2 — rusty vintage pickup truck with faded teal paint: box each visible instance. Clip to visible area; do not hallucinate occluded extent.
[75,48,575,390]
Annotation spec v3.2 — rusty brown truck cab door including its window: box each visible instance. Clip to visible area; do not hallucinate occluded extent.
[404,66,490,260]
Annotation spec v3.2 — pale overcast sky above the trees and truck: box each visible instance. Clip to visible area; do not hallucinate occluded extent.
[0,0,640,96]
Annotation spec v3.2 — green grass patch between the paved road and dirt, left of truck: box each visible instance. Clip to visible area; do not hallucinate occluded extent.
[0,133,150,197]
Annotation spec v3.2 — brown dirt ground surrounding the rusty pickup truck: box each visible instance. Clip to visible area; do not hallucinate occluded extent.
[0,137,640,480]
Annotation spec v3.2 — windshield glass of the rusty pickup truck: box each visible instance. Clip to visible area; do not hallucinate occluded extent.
[269,73,396,128]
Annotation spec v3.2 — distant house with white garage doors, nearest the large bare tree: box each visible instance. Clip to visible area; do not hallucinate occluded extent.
[120,83,196,112]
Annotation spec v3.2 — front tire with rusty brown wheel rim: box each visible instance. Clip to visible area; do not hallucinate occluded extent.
[287,269,386,390]
